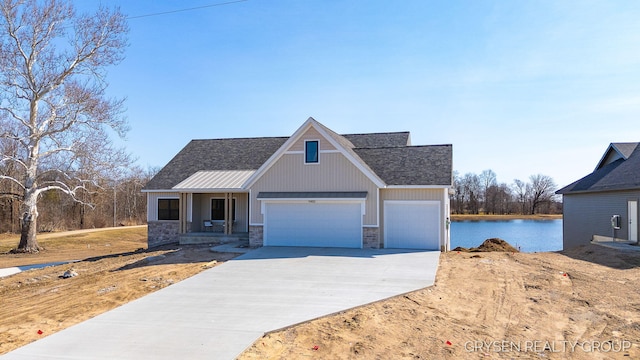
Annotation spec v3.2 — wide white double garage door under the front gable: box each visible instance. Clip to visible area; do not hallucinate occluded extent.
[264,201,362,248]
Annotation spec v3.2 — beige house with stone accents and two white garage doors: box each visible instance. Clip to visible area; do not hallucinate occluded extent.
[143,118,452,251]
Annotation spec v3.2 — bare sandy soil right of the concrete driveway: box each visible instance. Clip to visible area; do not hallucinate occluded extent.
[240,245,640,359]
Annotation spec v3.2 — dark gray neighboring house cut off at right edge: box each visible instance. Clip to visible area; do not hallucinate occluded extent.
[556,143,640,249]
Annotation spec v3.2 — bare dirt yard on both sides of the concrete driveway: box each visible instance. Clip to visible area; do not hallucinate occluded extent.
[0,228,640,359]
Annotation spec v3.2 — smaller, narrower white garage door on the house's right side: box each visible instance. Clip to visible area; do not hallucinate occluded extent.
[384,201,440,250]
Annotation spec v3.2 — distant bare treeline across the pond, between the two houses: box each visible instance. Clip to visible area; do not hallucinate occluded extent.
[450,170,562,215]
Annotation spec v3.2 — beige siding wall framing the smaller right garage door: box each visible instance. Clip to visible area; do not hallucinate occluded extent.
[380,188,450,250]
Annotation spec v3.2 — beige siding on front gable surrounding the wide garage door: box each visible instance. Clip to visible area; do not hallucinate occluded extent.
[251,152,378,226]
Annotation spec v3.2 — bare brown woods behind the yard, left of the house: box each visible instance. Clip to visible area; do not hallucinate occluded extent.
[0,166,155,233]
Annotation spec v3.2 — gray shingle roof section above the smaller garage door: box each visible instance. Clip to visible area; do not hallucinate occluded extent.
[354,145,453,186]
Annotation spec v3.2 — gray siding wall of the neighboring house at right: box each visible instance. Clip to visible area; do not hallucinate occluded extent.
[562,190,640,249]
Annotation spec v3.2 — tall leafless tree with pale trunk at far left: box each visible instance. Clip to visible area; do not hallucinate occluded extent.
[0,0,128,252]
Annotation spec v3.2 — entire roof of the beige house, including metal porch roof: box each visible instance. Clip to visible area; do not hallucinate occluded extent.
[144,118,453,191]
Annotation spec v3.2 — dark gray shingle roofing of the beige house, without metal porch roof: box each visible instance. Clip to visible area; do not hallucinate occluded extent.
[145,123,452,190]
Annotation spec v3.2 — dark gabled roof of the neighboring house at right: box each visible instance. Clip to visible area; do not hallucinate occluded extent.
[556,143,640,195]
